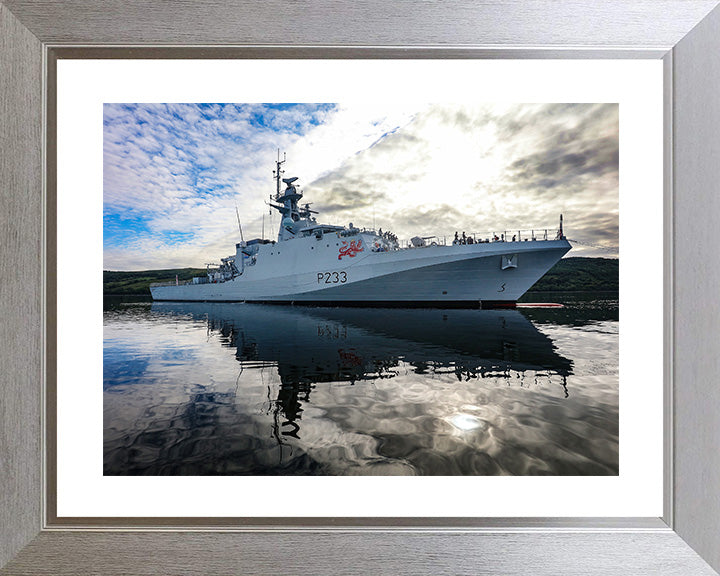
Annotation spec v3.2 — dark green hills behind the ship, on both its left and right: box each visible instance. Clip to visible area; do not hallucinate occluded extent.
[103,258,619,296]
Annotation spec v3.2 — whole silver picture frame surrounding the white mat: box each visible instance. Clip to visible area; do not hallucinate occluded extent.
[0,0,720,576]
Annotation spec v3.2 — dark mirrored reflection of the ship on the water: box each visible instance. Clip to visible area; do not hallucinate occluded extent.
[152,303,572,441]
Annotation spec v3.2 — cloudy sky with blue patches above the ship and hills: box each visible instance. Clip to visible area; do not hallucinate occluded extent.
[103,103,618,270]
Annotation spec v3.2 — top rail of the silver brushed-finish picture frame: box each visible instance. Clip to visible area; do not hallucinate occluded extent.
[0,0,716,49]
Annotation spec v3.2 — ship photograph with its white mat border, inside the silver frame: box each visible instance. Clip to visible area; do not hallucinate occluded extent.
[63,59,652,523]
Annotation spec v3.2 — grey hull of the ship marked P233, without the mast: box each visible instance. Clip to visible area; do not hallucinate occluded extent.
[151,237,570,306]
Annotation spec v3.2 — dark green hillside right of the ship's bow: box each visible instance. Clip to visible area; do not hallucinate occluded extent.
[529,258,620,292]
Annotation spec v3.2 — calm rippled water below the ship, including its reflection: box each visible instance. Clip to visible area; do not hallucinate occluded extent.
[103,295,618,475]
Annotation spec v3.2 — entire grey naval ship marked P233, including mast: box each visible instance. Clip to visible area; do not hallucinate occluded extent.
[150,153,570,308]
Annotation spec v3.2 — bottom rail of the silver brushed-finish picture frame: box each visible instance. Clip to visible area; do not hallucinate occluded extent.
[0,532,715,576]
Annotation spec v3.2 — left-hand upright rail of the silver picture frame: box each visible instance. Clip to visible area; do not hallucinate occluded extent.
[0,4,42,566]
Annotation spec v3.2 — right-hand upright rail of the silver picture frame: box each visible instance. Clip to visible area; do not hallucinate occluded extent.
[673,4,720,569]
